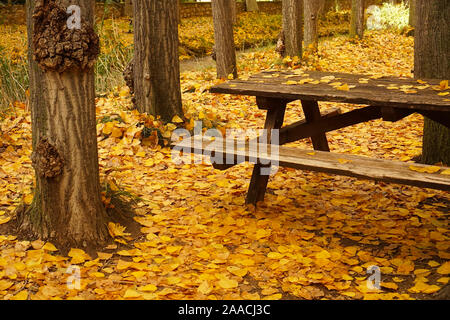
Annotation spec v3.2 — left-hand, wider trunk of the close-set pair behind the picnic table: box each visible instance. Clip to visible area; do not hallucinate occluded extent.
[282,0,303,58]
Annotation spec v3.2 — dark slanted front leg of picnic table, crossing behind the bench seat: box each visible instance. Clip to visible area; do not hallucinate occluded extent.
[246,99,286,204]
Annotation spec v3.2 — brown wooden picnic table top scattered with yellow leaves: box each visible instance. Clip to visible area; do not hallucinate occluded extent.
[211,69,450,112]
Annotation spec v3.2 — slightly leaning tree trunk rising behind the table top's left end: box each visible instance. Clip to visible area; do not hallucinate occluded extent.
[211,0,237,79]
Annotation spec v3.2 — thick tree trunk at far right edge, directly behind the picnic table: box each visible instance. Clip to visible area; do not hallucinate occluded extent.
[414,0,450,165]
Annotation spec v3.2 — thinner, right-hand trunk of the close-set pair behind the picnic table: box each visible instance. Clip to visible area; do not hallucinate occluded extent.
[304,0,324,52]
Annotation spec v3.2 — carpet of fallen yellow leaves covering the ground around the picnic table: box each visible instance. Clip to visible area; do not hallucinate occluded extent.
[0,32,450,299]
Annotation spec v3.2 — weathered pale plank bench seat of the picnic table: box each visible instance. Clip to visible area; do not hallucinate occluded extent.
[174,138,450,191]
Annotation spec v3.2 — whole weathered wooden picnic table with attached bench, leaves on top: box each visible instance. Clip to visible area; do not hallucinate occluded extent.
[183,70,450,204]
